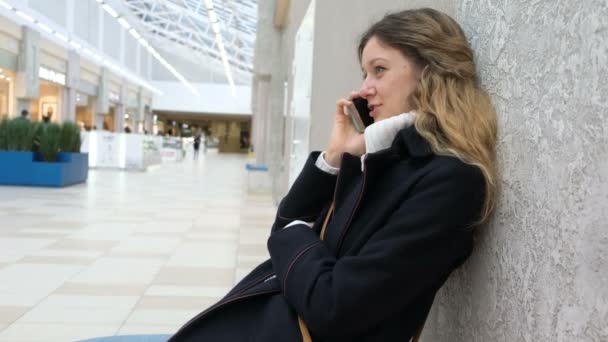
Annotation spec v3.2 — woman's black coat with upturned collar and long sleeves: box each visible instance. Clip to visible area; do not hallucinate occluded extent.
[171,127,484,342]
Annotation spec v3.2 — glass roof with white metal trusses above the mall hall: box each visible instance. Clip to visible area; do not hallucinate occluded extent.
[123,0,258,80]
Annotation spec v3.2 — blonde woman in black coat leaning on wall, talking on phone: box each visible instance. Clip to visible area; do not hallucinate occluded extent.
[84,9,498,342]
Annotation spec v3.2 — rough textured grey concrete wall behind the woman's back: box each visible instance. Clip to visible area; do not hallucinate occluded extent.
[423,0,608,342]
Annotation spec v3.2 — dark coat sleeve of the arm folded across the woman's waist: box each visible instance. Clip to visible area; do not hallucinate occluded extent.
[268,165,484,340]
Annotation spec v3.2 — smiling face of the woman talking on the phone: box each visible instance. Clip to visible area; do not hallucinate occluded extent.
[359,37,422,121]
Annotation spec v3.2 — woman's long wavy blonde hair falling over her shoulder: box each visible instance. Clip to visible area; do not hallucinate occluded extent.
[359,8,498,223]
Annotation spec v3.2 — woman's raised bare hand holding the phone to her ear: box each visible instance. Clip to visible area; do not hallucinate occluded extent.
[325,92,365,168]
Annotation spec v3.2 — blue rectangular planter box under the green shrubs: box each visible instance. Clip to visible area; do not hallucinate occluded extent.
[0,151,89,187]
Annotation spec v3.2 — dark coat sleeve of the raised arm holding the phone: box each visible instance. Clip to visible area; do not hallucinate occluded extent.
[272,152,337,232]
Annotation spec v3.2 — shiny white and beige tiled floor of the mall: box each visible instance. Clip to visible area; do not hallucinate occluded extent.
[0,153,276,342]
